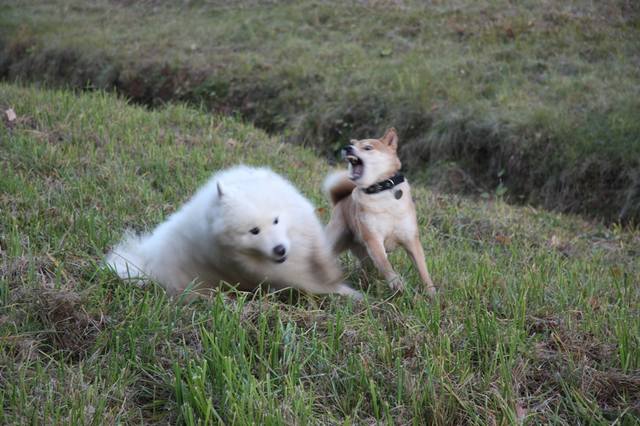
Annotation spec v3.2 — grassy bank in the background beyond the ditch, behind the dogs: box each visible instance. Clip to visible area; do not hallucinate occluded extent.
[0,0,640,220]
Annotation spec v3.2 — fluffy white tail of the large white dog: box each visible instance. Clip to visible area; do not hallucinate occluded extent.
[105,231,147,285]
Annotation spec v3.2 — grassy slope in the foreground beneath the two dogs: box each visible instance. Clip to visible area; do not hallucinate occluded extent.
[0,84,640,424]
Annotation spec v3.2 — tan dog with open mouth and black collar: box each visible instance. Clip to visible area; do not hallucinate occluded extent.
[325,128,435,294]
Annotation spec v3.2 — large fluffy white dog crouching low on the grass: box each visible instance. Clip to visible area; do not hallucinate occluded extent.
[106,166,360,298]
